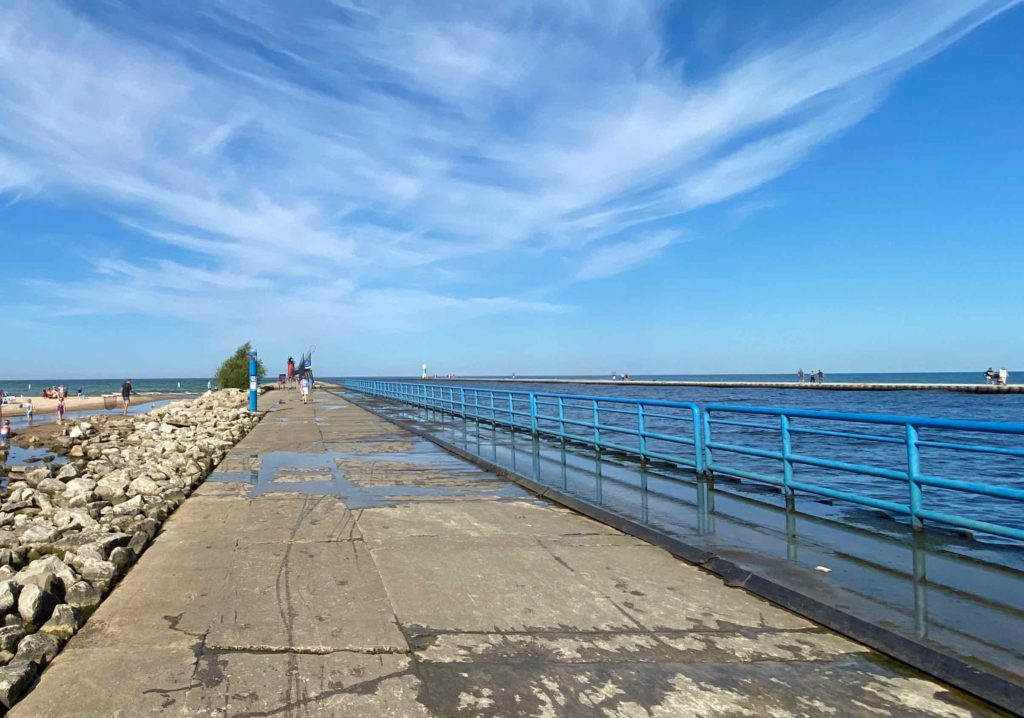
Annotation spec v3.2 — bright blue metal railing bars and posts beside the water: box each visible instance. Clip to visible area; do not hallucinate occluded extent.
[345,379,1024,542]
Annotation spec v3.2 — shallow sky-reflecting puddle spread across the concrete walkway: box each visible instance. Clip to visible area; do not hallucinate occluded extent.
[207,440,532,509]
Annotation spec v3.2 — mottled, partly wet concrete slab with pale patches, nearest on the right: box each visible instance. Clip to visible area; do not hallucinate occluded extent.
[409,656,989,718]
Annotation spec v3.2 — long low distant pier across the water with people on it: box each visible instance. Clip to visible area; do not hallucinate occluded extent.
[444,377,1024,394]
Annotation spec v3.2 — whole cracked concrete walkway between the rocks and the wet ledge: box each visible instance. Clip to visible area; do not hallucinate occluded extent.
[10,392,993,718]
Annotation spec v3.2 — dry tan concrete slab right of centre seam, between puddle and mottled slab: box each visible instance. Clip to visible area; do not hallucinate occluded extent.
[372,538,811,632]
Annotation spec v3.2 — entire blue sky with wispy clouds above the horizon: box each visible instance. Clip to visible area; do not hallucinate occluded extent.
[0,0,1024,378]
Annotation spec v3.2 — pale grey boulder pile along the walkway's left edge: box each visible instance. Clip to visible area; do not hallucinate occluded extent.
[0,390,258,715]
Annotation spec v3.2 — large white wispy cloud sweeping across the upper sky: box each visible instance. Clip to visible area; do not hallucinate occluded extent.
[0,0,1016,321]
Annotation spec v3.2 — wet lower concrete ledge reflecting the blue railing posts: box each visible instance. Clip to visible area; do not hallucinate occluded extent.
[359,396,1024,696]
